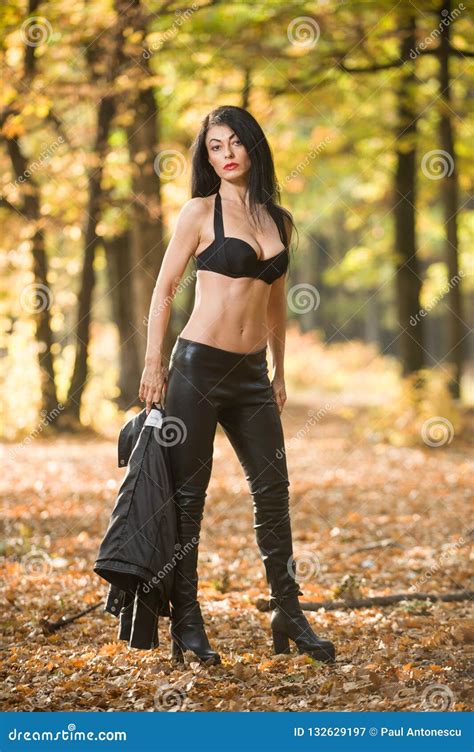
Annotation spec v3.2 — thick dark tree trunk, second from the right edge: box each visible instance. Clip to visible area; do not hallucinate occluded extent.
[394,17,424,382]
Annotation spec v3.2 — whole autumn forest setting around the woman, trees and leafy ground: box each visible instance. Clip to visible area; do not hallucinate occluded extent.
[0,0,474,711]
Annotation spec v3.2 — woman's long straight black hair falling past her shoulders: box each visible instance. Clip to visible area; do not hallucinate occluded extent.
[191,105,296,260]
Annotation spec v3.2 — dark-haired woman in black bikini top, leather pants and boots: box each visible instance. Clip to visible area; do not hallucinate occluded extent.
[139,107,335,663]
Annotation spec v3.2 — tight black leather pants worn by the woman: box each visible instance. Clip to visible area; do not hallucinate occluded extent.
[165,336,302,621]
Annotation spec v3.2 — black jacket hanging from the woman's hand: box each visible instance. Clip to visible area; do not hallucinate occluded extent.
[94,403,178,649]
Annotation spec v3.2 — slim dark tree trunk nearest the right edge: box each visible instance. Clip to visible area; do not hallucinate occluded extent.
[439,0,465,398]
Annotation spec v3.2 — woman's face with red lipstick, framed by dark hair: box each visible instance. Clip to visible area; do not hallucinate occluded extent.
[206,125,250,181]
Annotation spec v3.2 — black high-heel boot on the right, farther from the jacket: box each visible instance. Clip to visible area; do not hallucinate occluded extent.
[270,595,336,662]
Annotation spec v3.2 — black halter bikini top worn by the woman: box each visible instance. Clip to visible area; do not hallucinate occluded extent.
[194,192,288,285]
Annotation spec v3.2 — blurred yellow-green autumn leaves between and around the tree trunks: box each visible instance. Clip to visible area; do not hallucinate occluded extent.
[0,0,472,432]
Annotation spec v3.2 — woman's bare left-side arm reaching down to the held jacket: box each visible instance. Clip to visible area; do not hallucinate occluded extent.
[139,198,203,412]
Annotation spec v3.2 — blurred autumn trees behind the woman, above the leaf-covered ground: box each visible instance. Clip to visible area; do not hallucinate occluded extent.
[0,0,474,439]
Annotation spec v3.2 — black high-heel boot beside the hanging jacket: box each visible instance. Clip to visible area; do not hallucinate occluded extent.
[170,601,221,665]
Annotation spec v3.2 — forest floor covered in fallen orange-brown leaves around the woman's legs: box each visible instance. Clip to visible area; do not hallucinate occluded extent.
[0,390,474,711]
